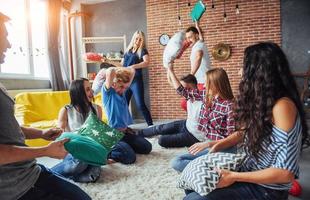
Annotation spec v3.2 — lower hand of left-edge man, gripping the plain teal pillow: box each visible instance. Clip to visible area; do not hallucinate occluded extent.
[46,138,69,159]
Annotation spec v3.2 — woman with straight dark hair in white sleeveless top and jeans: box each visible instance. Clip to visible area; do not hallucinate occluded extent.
[52,78,102,182]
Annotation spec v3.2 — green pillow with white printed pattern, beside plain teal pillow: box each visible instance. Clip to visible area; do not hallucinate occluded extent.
[78,112,124,151]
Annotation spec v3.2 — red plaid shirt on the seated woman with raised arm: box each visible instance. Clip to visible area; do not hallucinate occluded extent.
[177,86,235,140]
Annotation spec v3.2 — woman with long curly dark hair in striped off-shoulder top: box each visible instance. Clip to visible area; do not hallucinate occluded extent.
[184,42,309,200]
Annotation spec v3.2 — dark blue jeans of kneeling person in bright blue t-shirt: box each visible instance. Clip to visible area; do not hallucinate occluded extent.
[108,134,152,164]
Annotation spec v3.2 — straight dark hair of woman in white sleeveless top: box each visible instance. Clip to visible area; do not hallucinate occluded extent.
[69,78,97,120]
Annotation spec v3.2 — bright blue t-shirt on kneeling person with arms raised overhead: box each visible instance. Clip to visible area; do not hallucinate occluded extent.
[101,84,133,128]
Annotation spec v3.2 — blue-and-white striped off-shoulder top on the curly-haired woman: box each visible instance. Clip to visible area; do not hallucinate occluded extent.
[241,116,302,190]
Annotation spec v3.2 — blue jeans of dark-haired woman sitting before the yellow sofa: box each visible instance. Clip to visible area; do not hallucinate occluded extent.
[51,154,101,183]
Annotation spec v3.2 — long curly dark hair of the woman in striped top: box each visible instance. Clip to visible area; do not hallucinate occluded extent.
[236,42,309,157]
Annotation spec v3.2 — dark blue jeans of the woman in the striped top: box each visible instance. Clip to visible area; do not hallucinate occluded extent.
[183,182,288,200]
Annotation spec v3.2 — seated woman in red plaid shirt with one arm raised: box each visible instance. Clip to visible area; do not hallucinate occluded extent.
[168,64,235,172]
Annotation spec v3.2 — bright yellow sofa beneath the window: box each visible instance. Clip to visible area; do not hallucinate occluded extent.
[15,91,107,146]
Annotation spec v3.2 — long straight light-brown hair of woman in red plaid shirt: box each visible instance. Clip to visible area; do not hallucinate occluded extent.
[206,68,234,102]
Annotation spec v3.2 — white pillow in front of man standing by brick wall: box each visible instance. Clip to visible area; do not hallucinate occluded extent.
[163,31,185,68]
